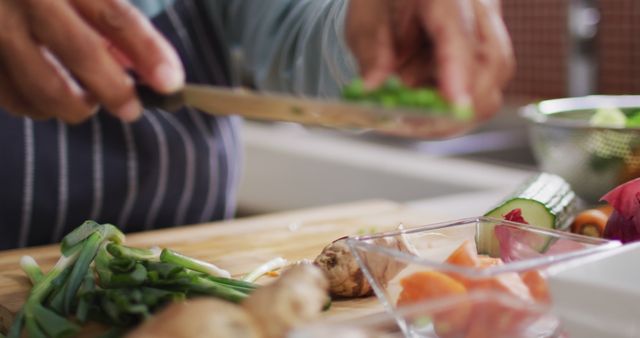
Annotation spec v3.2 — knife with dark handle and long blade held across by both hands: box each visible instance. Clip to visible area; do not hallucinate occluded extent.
[136,84,477,139]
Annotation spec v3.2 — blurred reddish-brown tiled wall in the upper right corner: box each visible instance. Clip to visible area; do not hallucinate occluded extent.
[502,0,640,99]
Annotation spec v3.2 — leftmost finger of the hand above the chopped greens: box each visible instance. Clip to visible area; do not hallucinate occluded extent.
[346,0,395,88]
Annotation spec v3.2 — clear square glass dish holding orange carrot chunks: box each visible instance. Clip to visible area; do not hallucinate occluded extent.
[347,217,621,338]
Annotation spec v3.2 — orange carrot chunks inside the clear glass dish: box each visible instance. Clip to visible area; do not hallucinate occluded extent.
[397,241,550,338]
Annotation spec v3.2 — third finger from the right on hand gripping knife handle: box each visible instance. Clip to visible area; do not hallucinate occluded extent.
[0,1,92,123]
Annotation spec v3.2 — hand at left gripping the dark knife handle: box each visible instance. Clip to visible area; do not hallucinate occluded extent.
[0,0,184,123]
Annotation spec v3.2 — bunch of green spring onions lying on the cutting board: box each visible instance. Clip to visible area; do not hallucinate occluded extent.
[8,221,257,338]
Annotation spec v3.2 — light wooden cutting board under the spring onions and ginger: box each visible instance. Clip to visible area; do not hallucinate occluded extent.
[0,200,447,332]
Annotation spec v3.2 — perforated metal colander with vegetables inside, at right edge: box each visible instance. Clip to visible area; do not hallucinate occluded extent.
[521,95,640,202]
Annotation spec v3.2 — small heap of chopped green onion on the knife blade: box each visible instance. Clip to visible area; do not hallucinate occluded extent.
[342,77,473,120]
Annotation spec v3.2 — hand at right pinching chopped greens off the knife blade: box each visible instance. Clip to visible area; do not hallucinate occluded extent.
[346,0,515,119]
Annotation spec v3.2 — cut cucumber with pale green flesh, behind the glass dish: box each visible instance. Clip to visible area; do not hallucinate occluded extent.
[476,173,577,257]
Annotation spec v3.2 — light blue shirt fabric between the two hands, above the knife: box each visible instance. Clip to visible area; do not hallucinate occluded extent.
[204,0,357,97]
